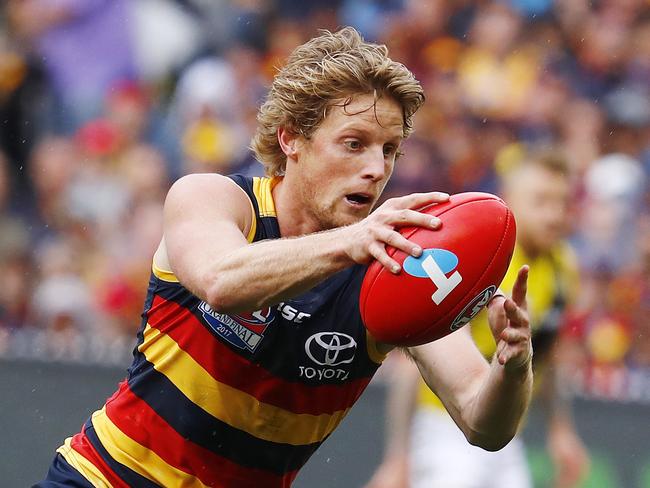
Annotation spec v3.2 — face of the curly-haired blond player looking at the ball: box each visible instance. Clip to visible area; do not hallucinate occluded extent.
[287,94,403,229]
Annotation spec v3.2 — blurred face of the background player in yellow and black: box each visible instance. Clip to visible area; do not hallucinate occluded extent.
[505,165,570,253]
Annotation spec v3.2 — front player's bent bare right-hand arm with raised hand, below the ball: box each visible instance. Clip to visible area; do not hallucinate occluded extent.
[409,268,533,450]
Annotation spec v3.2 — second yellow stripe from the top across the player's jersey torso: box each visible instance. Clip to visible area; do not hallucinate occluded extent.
[92,407,206,488]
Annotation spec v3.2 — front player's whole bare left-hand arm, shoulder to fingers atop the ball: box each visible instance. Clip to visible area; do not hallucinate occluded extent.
[164,175,447,312]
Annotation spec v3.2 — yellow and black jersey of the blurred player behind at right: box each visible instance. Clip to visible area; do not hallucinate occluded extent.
[419,244,578,409]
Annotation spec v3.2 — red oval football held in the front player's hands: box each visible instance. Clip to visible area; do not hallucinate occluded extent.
[359,192,516,346]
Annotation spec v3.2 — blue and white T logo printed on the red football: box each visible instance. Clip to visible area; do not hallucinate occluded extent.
[404,249,463,305]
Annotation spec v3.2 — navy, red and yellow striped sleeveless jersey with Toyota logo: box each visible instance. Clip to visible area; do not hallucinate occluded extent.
[58,175,383,488]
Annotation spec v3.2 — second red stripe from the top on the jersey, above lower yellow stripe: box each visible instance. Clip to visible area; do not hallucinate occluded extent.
[106,382,297,488]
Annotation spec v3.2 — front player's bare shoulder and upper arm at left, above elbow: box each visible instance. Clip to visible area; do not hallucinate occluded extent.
[163,174,252,299]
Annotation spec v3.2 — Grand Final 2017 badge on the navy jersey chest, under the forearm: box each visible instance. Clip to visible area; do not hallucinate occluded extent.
[199,302,275,352]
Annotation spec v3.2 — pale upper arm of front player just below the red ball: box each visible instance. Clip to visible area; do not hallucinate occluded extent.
[409,327,489,423]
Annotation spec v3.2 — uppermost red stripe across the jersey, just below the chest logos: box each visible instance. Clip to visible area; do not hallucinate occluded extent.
[148,296,370,415]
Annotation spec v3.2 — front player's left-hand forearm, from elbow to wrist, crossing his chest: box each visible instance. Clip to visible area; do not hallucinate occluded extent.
[204,229,354,312]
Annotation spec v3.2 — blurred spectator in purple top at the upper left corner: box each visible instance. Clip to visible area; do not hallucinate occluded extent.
[6,0,136,133]
